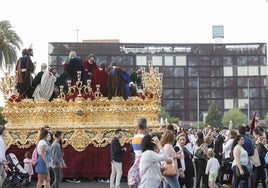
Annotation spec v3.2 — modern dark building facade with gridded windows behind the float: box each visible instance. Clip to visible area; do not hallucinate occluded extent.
[49,40,268,121]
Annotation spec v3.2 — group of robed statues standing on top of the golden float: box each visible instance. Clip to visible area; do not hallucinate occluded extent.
[16,49,142,101]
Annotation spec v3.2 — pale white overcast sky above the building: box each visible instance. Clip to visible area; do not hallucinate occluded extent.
[0,0,268,106]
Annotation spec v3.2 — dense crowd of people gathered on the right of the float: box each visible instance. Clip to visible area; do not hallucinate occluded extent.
[123,118,268,188]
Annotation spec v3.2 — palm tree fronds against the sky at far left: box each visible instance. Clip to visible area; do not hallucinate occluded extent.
[0,20,23,67]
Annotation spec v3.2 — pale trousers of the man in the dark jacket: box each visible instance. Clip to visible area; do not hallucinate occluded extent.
[110,160,122,188]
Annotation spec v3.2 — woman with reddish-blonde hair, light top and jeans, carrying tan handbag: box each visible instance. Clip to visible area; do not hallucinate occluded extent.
[161,131,183,188]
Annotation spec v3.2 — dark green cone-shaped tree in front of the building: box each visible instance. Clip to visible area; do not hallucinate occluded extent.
[206,101,222,128]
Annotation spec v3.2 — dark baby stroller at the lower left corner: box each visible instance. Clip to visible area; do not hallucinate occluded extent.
[3,153,30,187]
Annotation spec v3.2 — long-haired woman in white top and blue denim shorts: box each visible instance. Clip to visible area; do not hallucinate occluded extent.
[35,127,51,188]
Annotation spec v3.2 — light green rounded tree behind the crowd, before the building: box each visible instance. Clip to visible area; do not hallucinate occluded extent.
[222,108,248,128]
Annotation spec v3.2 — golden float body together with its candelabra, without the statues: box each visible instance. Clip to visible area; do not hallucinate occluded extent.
[0,62,163,151]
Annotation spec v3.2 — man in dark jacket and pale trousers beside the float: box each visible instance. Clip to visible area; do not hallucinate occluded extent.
[110,129,127,188]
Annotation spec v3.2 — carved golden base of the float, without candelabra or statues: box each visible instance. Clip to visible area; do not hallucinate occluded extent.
[3,97,160,151]
